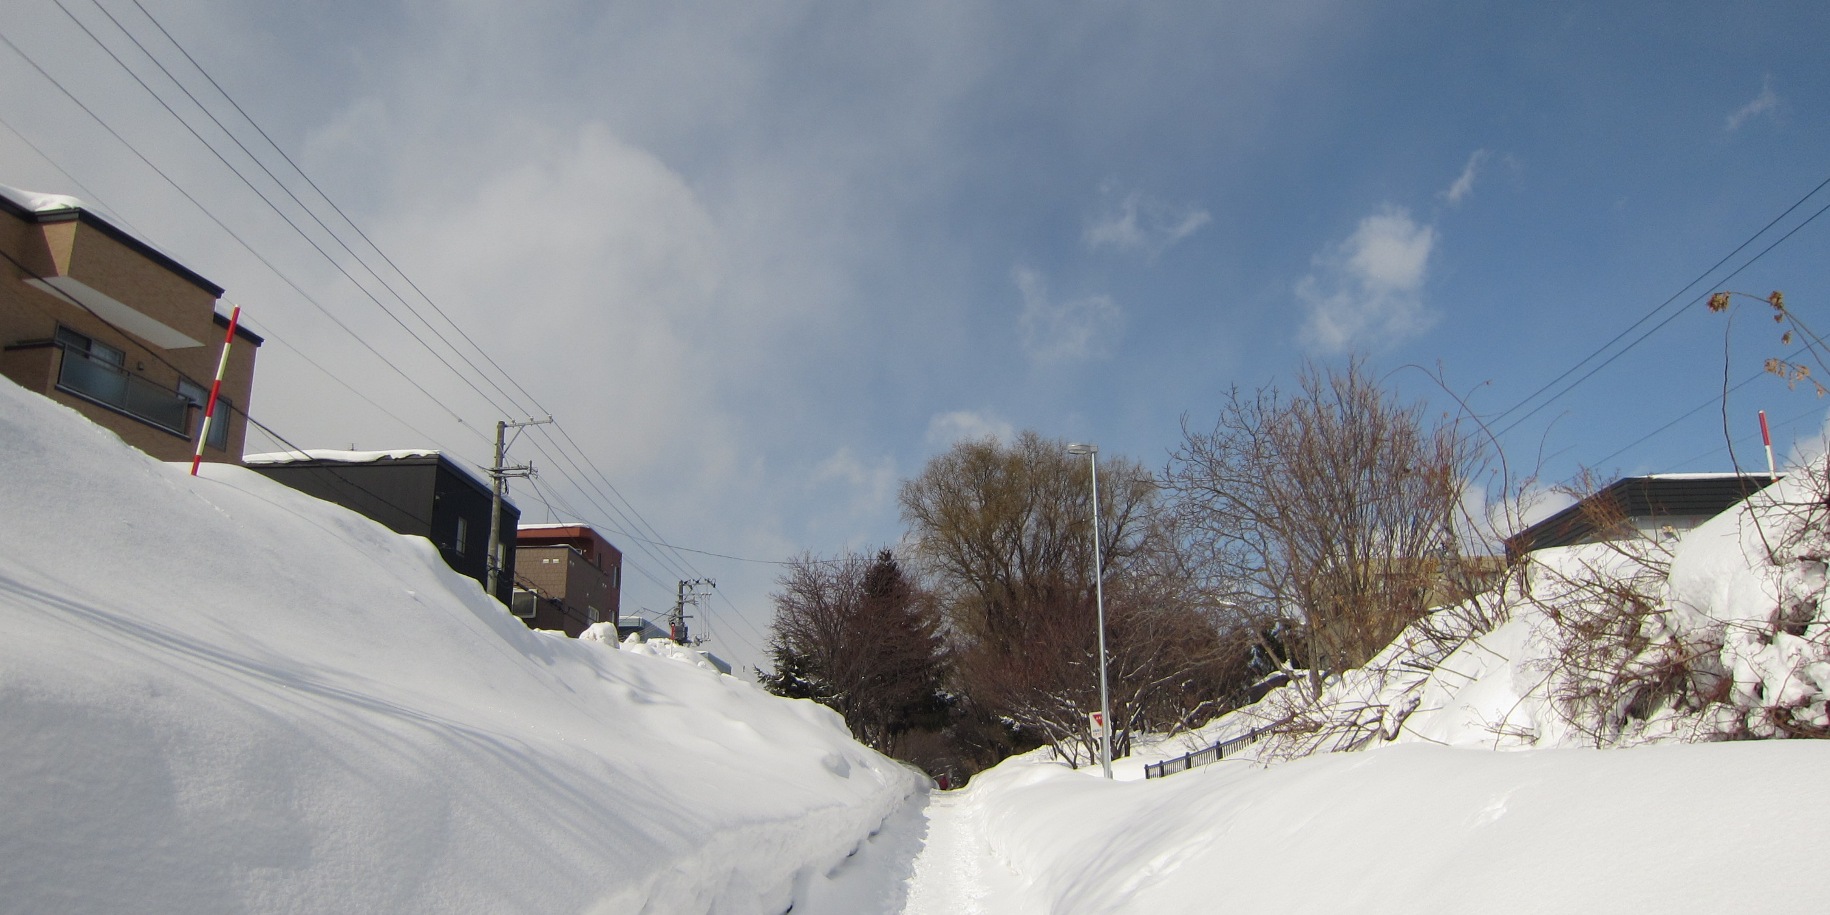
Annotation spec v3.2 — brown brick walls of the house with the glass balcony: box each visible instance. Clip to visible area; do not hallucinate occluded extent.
[0,207,258,461]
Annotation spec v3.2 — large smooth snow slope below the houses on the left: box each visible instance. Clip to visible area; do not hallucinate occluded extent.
[0,373,917,915]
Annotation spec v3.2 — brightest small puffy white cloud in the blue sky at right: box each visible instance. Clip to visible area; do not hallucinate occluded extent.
[1296,207,1437,353]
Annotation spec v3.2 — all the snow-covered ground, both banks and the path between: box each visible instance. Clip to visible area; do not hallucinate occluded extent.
[0,366,1830,915]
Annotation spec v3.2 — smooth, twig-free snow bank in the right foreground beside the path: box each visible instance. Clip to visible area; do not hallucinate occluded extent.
[964,741,1830,915]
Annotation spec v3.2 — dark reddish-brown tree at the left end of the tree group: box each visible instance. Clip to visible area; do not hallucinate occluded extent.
[763,549,946,752]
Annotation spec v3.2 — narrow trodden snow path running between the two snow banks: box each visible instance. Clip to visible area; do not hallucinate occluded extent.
[794,791,1027,915]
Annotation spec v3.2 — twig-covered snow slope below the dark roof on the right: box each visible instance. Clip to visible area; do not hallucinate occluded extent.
[1162,470,1830,758]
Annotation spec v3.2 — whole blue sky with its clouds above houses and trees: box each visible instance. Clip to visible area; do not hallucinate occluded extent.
[0,0,1830,673]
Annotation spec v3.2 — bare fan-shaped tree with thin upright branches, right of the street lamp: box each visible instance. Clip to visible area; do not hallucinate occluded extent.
[1164,361,1475,697]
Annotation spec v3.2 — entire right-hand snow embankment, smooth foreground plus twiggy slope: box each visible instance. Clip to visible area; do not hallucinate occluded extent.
[944,474,1830,915]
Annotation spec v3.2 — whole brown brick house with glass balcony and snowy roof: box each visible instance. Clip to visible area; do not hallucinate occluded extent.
[0,185,262,463]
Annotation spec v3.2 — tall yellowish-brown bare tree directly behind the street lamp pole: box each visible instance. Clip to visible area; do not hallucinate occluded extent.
[900,432,1219,761]
